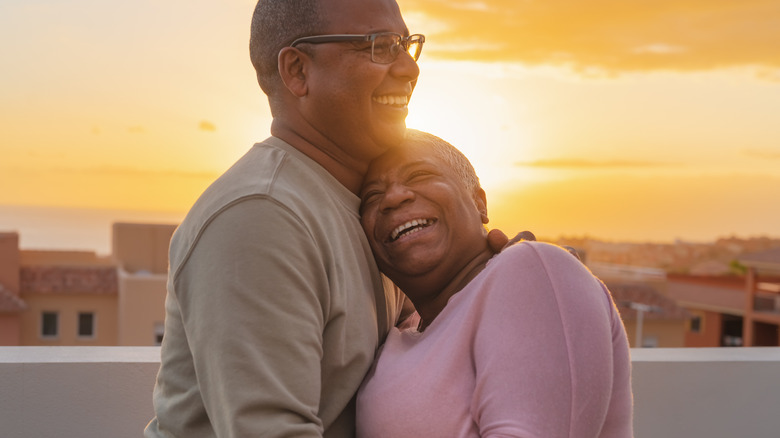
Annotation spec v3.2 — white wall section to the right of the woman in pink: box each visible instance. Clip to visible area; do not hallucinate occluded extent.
[631,347,780,438]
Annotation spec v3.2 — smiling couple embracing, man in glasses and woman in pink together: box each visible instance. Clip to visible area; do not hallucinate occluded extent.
[145,0,632,438]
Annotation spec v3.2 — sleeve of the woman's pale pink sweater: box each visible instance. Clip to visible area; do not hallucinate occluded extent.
[472,242,631,438]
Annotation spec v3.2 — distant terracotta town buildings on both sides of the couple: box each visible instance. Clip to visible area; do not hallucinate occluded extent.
[0,222,780,348]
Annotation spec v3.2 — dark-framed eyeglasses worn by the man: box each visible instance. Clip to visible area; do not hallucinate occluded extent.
[290,32,425,64]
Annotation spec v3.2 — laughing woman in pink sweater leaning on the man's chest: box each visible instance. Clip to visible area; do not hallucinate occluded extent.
[357,130,632,438]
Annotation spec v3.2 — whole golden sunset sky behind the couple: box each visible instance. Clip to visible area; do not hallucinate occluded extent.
[0,0,780,245]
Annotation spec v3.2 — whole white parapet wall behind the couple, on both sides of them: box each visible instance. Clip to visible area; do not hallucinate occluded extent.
[0,347,780,438]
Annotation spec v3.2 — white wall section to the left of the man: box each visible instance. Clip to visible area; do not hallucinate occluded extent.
[0,347,160,438]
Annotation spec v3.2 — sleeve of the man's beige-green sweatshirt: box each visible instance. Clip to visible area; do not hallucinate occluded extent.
[174,198,329,437]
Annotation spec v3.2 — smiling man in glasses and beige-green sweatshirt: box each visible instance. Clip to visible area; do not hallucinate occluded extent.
[145,0,424,437]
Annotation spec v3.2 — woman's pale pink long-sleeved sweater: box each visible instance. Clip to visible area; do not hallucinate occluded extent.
[357,242,633,438]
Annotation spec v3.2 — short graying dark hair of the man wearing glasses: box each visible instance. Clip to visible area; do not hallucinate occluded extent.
[249,0,323,97]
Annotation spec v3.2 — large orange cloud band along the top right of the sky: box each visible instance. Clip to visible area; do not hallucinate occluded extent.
[399,0,780,73]
